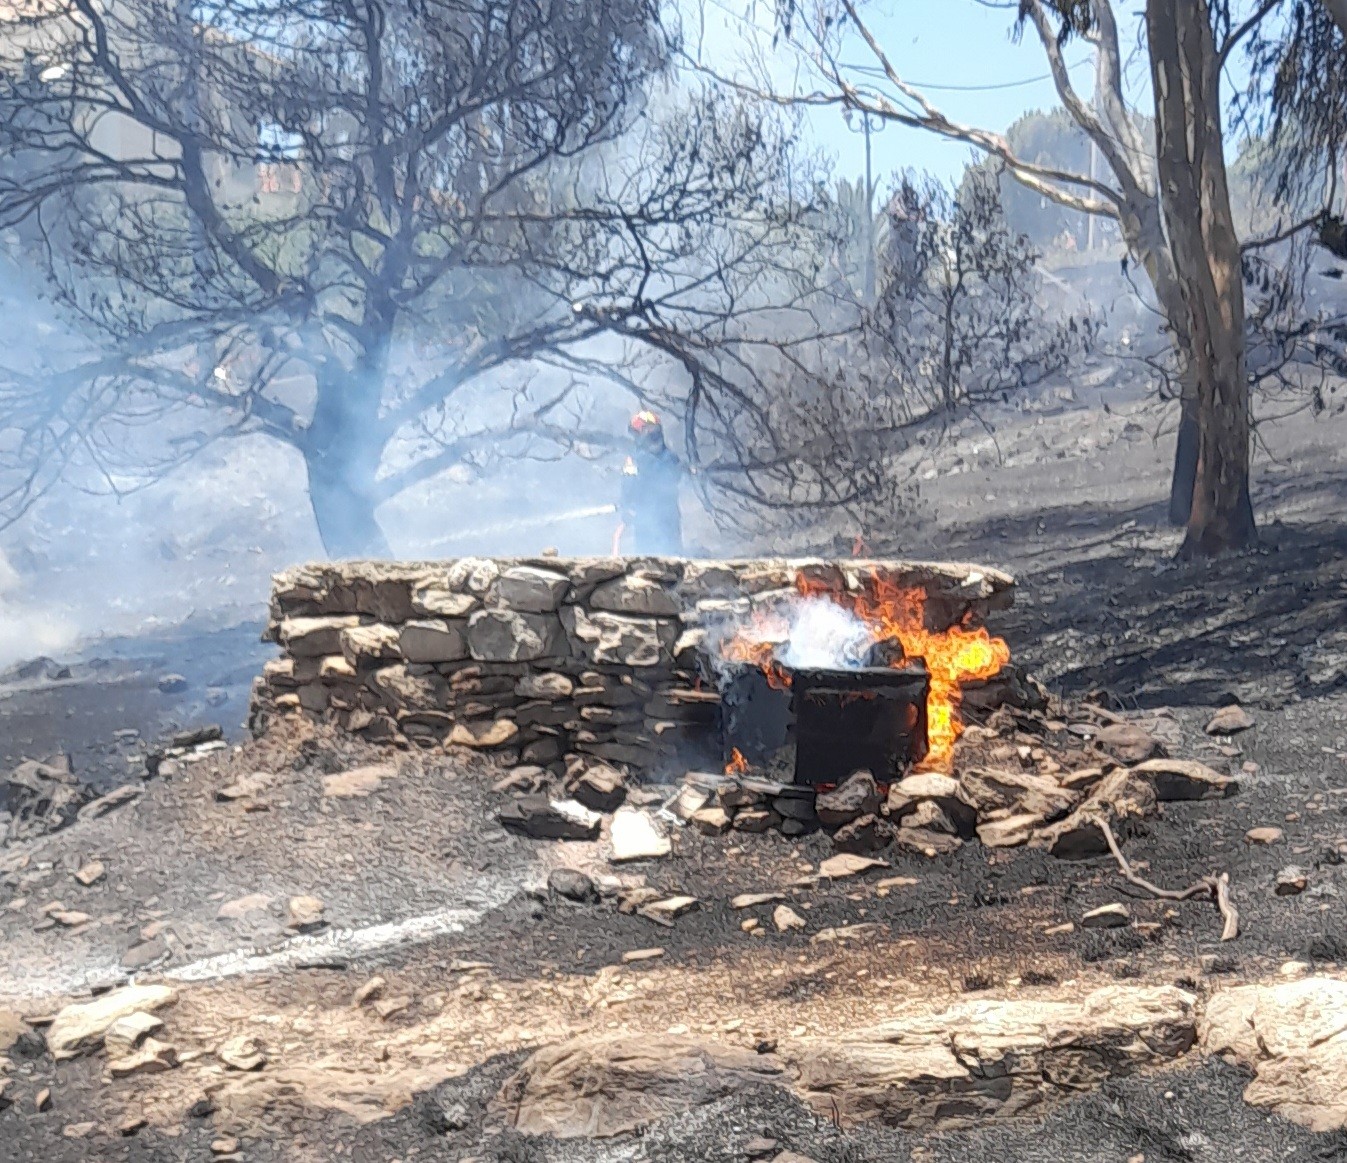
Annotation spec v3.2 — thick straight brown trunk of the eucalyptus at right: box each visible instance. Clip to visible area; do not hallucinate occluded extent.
[1146,0,1255,557]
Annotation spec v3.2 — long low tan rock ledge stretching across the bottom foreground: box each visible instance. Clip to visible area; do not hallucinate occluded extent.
[493,985,1196,1139]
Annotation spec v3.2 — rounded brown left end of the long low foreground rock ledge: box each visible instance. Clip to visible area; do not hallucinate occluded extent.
[493,1035,781,1139]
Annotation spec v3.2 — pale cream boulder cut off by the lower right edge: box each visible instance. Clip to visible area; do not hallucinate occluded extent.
[1200,977,1347,1131]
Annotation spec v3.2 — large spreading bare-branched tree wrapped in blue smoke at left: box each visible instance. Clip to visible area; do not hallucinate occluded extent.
[0,0,831,557]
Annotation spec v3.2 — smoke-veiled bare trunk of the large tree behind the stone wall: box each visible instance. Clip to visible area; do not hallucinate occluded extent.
[302,373,392,559]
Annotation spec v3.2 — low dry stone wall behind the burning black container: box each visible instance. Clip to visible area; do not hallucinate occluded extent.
[252,557,1013,772]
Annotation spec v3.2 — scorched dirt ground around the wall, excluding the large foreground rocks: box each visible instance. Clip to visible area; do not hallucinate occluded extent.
[0,385,1347,1163]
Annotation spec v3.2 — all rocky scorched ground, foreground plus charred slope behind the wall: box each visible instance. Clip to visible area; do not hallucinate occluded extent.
[0,385,1347,1163]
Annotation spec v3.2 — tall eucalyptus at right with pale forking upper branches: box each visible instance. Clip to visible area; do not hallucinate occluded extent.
[723,0,1320,553]
